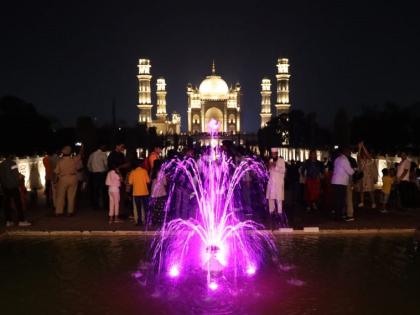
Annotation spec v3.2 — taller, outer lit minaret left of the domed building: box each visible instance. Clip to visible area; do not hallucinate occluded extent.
[137,59,152,123]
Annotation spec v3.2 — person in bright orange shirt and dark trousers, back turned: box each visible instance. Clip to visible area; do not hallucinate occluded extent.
[128,160,150,225]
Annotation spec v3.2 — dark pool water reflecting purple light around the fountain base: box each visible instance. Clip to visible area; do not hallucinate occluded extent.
[0,236,420,315]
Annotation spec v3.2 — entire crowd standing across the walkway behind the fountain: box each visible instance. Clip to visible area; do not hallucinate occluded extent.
[0,142,420,228]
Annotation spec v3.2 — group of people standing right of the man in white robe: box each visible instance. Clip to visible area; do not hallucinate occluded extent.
[282,142,420,221]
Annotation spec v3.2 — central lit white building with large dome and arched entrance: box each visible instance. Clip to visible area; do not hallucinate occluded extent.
[187,62,241,134]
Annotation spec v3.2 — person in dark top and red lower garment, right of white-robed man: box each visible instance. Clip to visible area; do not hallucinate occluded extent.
[302,150,324,211]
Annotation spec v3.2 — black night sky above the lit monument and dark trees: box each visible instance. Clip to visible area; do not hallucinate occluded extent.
[0,1,420,131]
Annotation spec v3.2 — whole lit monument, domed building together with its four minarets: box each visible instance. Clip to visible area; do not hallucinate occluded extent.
[137,58,291,134]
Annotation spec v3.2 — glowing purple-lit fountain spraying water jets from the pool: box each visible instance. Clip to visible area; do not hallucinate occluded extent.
[152,120,276,292]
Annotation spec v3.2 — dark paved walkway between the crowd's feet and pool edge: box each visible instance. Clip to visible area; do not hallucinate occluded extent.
[0,193,420,233]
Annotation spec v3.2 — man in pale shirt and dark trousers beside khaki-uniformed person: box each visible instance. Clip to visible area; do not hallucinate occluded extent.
[87,145,108,209]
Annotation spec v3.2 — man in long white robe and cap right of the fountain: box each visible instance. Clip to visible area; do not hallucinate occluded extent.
[266,148,286,227]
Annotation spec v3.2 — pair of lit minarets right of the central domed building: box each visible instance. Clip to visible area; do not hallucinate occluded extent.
[260,58,290,128]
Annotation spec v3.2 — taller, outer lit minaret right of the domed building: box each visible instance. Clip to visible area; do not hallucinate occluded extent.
[276,58,290,115]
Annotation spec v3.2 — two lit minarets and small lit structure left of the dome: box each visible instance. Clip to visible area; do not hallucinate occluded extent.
[137,59,181,134]
